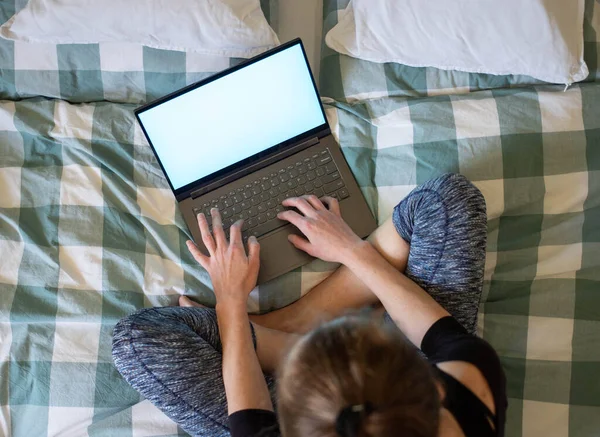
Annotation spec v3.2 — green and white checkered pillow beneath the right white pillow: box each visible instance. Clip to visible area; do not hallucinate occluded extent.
[320,0,600,102]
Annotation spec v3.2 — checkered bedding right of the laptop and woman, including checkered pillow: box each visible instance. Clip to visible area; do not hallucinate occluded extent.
[320,0,600,437]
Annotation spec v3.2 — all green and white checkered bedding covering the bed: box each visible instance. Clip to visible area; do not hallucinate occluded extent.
[0,0,600,437]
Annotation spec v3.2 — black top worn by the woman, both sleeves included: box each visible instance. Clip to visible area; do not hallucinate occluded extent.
[229,317,508,437]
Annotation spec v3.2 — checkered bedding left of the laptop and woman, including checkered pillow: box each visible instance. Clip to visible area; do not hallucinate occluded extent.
[0,0,286,437]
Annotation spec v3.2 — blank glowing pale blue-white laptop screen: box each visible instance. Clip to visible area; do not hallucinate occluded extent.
[138,44,325,190]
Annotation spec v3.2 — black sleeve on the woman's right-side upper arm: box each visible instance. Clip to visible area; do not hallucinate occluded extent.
[421,316,508,435]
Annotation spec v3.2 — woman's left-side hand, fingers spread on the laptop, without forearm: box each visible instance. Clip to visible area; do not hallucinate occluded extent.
[187,208,260,308]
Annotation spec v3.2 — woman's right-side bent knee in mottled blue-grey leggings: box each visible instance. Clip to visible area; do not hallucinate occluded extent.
[392,174,487,333]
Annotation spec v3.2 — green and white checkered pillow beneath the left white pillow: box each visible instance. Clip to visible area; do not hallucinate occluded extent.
[0,0,278,103]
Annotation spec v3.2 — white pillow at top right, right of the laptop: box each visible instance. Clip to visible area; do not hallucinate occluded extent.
[325,0,588,84]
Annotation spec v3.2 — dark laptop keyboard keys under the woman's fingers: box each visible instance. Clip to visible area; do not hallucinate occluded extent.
[194,150,350,240]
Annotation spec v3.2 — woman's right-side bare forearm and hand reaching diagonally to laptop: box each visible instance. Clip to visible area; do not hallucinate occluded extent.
[279,196,449,347]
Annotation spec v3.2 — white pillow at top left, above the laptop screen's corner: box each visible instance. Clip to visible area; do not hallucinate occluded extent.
[0,0,279,58]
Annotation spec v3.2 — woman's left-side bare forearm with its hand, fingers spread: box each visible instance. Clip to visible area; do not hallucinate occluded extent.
[187,208,273,415]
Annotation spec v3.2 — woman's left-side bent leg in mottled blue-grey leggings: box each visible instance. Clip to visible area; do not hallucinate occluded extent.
[113,307,274,437]
